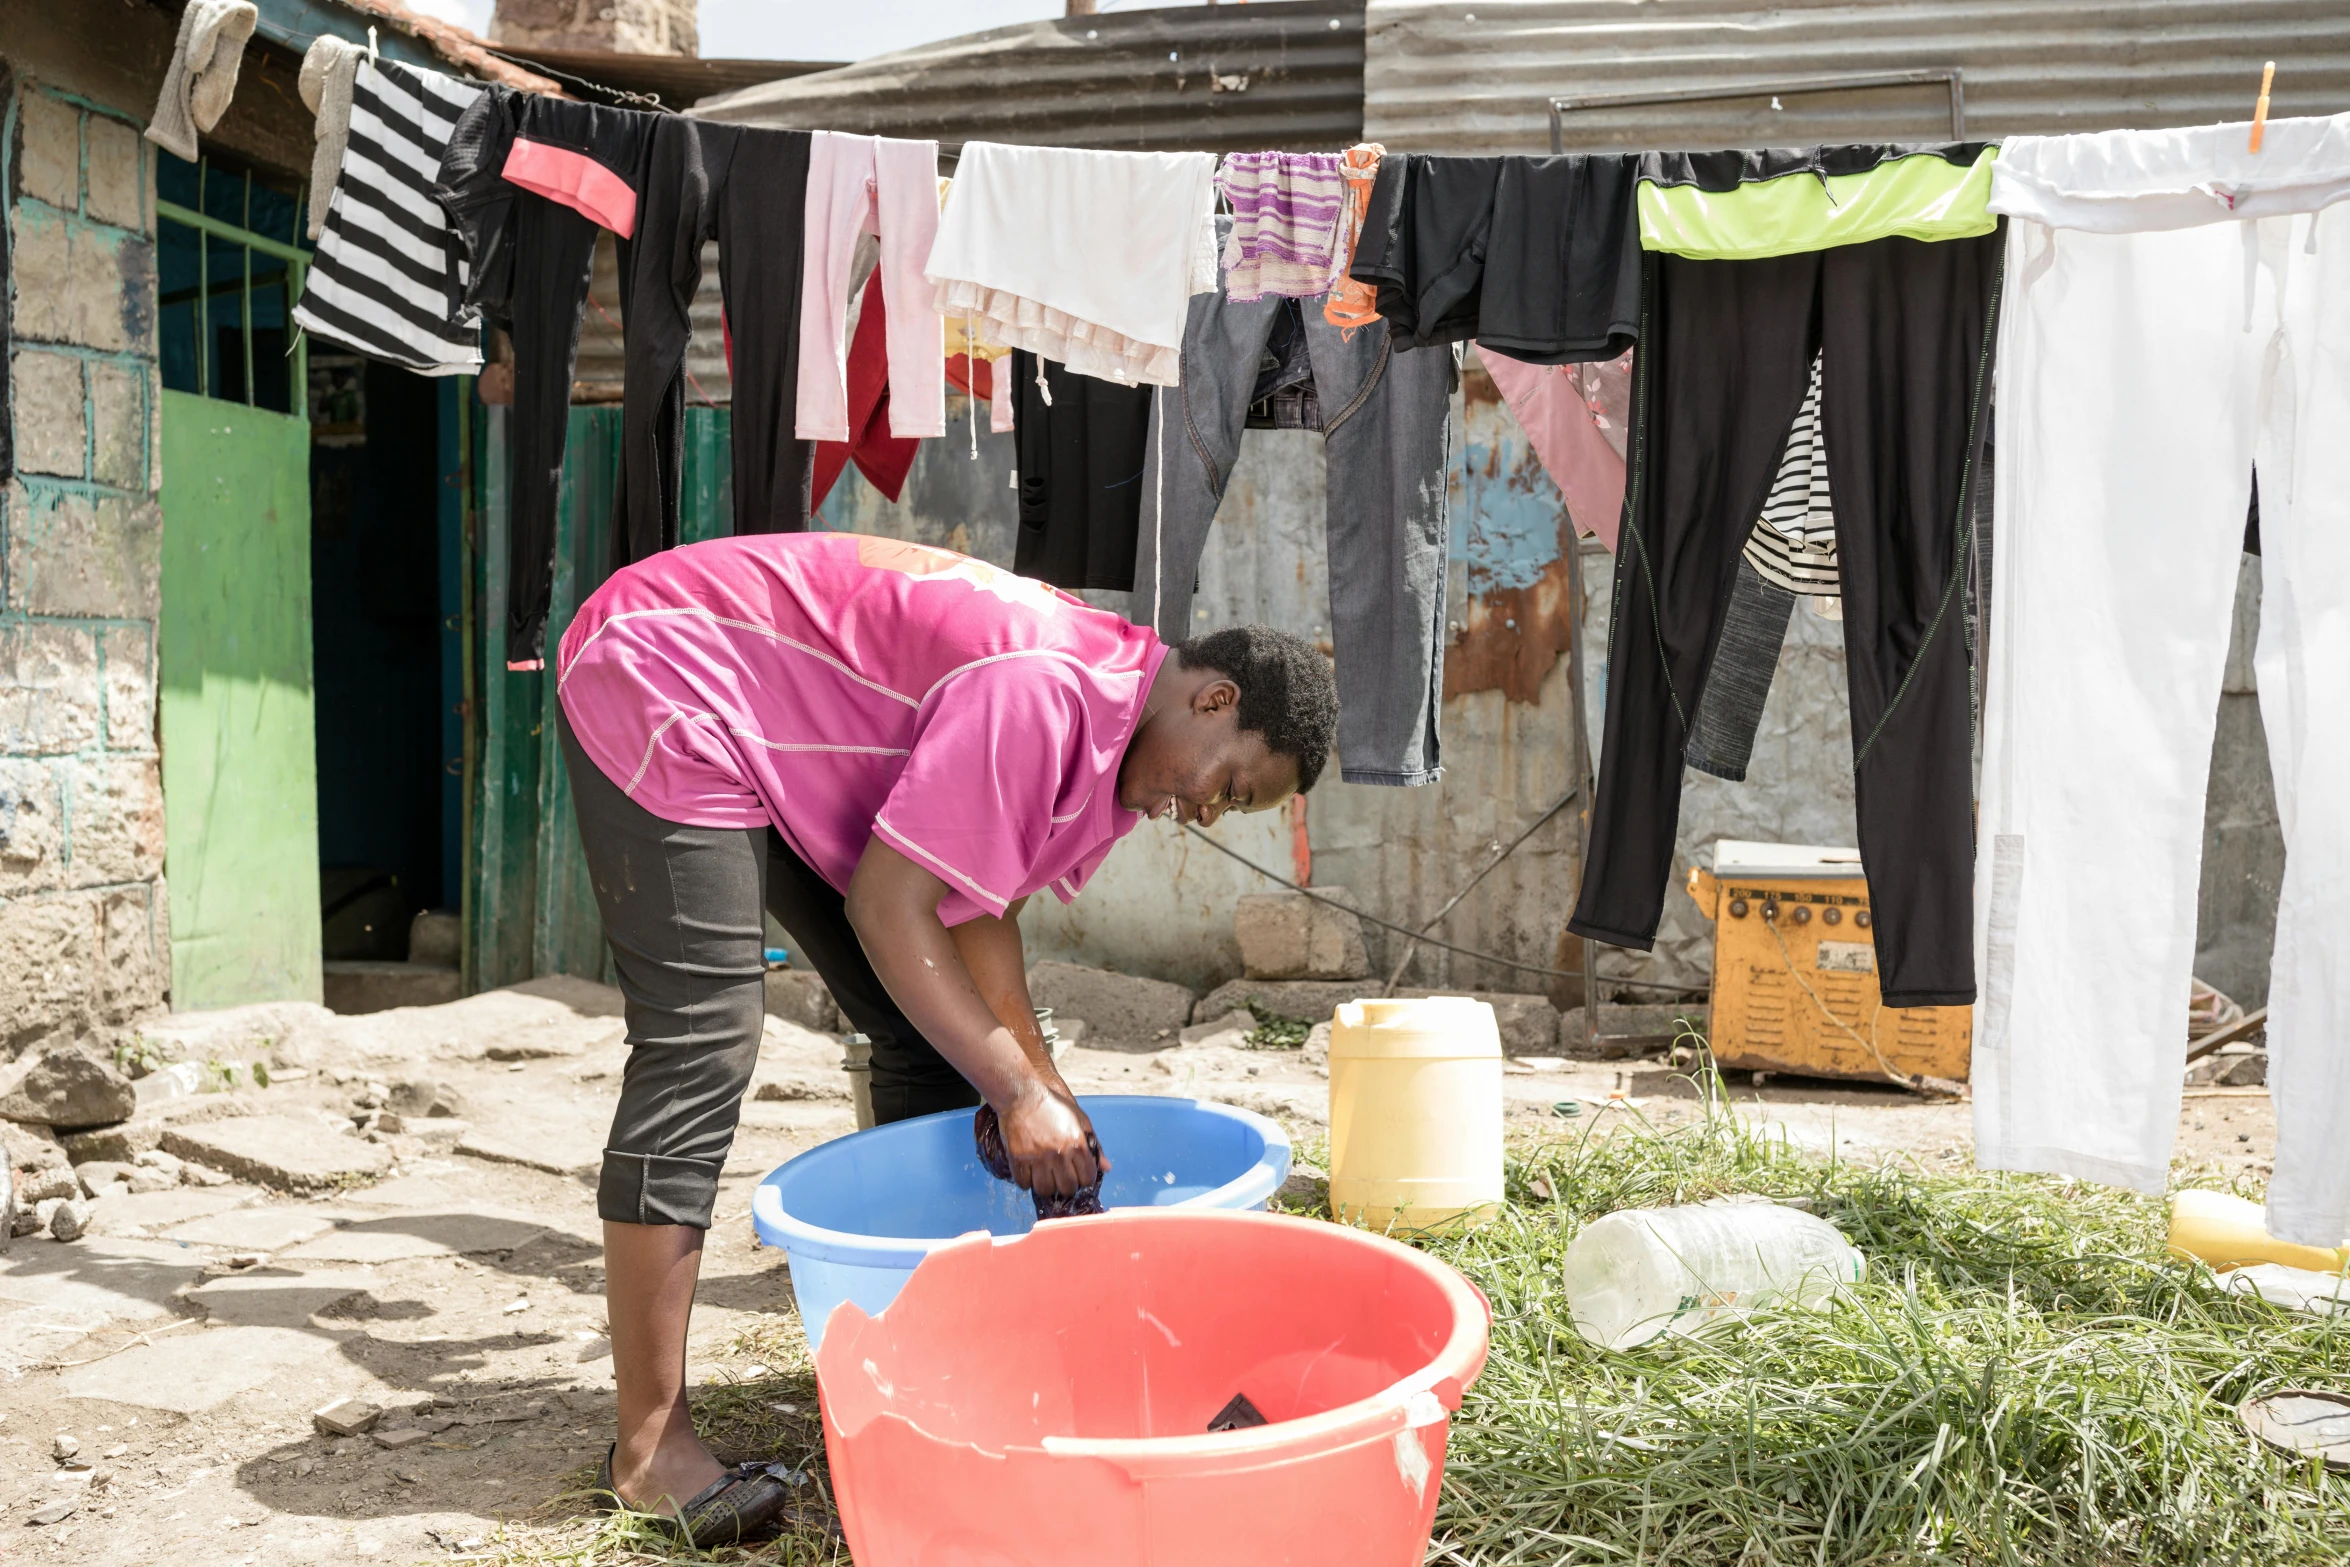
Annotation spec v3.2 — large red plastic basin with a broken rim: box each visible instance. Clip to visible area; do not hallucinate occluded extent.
[815,1210,1490,1567]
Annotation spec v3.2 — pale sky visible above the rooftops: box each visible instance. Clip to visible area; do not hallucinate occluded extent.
[407,0,1187,61]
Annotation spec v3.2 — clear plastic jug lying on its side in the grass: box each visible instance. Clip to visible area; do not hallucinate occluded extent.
[1565,1198,1866,1349]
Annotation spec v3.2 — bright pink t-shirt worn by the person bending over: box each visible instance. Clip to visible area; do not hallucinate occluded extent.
[557,533,1166,926]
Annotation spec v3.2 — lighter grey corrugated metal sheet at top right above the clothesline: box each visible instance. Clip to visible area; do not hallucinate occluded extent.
[1363,0,2350,153]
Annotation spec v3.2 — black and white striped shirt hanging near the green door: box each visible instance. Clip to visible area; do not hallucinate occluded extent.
[294,59,482,376]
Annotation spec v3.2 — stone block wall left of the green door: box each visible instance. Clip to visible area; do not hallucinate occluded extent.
[0,66,172,1060]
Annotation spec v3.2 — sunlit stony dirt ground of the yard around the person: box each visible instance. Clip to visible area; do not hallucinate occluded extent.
[0,980,2275,1567]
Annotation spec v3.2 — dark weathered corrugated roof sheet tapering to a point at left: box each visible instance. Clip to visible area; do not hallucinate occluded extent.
[693,0,1363,153]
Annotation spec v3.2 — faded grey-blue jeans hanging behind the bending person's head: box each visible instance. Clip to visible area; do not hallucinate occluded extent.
[1133,263,1457,785]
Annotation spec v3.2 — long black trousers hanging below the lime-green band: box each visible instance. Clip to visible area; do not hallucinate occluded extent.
[1567,233,2005,1006]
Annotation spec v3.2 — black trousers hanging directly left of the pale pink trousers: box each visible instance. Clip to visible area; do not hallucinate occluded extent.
[613,115,813,566]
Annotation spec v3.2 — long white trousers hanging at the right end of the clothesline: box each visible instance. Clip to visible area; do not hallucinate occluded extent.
[1974,115,2350,1245]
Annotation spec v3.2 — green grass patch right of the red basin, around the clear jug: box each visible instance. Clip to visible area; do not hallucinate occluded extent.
[1429,1085,2350,1567]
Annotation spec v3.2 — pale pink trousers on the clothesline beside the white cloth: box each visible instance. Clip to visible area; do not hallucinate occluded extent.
[799,132,947,442]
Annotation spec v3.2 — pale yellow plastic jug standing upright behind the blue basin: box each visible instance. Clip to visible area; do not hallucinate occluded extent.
[1330,996,1502,1233]
